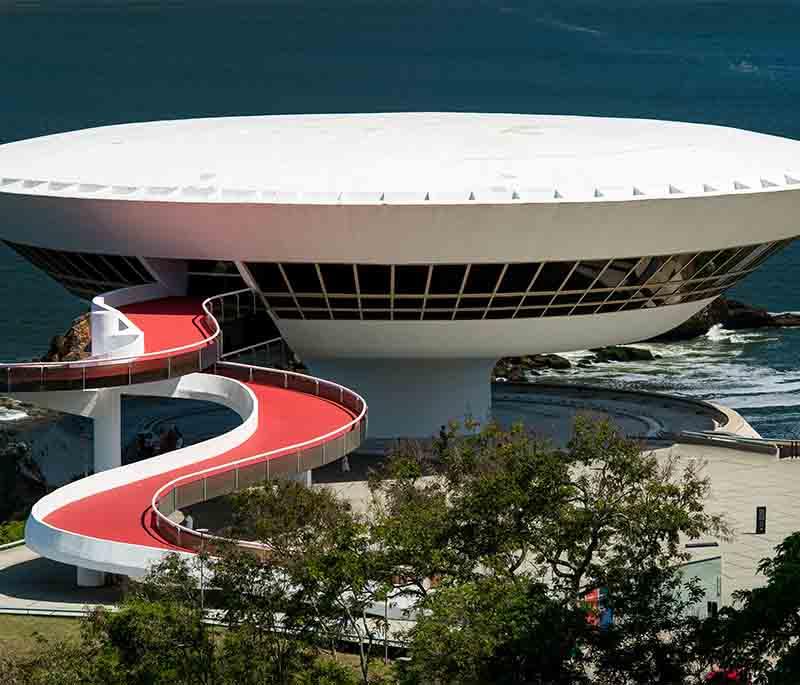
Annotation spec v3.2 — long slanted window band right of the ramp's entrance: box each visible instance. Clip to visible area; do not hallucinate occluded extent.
[247,241,790,321]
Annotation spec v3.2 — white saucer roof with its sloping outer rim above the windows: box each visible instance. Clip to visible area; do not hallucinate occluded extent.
[0,113,800,264]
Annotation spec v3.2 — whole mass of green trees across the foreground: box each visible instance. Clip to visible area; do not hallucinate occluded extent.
[0,419,800,685]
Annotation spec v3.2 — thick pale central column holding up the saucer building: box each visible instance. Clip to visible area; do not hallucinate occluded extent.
[304,358,495,438]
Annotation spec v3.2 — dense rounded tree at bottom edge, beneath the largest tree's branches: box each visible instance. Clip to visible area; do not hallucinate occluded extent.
[402,576,593,685]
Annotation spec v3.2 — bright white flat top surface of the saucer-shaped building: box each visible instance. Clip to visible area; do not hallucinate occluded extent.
[0,113,800,204]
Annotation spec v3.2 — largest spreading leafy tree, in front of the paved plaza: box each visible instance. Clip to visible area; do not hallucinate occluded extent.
[372,418,727,683]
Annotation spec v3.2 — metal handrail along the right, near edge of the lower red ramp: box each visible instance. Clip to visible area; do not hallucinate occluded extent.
[150,358,367,549]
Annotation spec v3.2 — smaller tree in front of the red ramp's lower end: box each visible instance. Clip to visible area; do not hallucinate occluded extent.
[227,481,389,683]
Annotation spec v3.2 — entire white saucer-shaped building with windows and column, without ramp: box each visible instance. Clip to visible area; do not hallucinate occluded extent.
[0,113,800,437]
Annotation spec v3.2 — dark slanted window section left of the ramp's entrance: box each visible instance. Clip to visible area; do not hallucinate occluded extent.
[5,241,155,300]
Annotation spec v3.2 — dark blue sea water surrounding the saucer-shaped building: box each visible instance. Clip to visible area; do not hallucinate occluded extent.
[0,0,800,436]
